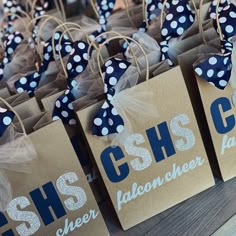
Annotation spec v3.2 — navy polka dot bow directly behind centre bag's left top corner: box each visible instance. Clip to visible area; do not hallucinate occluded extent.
[52,41,89,125]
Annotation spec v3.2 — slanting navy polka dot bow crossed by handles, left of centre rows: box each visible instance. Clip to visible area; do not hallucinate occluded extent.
[15,32,72,96]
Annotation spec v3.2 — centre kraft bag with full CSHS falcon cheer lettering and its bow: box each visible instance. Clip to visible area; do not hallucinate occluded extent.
[77,36,214,230]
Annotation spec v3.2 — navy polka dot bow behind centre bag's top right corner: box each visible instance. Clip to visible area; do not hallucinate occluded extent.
[160,0,195,66]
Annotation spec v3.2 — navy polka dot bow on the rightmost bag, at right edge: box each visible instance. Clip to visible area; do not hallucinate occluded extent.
[194,4,236,89]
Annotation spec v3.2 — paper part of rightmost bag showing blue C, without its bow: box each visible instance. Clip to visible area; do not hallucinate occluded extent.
[179,42,236,181]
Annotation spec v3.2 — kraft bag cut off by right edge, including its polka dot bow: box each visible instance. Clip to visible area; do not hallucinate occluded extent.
[179,4,236,181]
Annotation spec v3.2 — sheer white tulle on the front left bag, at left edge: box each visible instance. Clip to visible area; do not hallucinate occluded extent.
[0,126,37,211]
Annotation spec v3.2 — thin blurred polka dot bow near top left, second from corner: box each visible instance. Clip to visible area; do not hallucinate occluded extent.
[29,1,48,47]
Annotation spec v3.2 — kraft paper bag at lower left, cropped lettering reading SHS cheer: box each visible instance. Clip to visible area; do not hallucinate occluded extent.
[0,111,109,236]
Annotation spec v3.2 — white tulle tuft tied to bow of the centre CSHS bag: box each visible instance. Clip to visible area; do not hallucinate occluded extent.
[105,66,158,146]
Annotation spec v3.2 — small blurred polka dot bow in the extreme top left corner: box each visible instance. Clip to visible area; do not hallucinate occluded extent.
[3,0,22,33]
